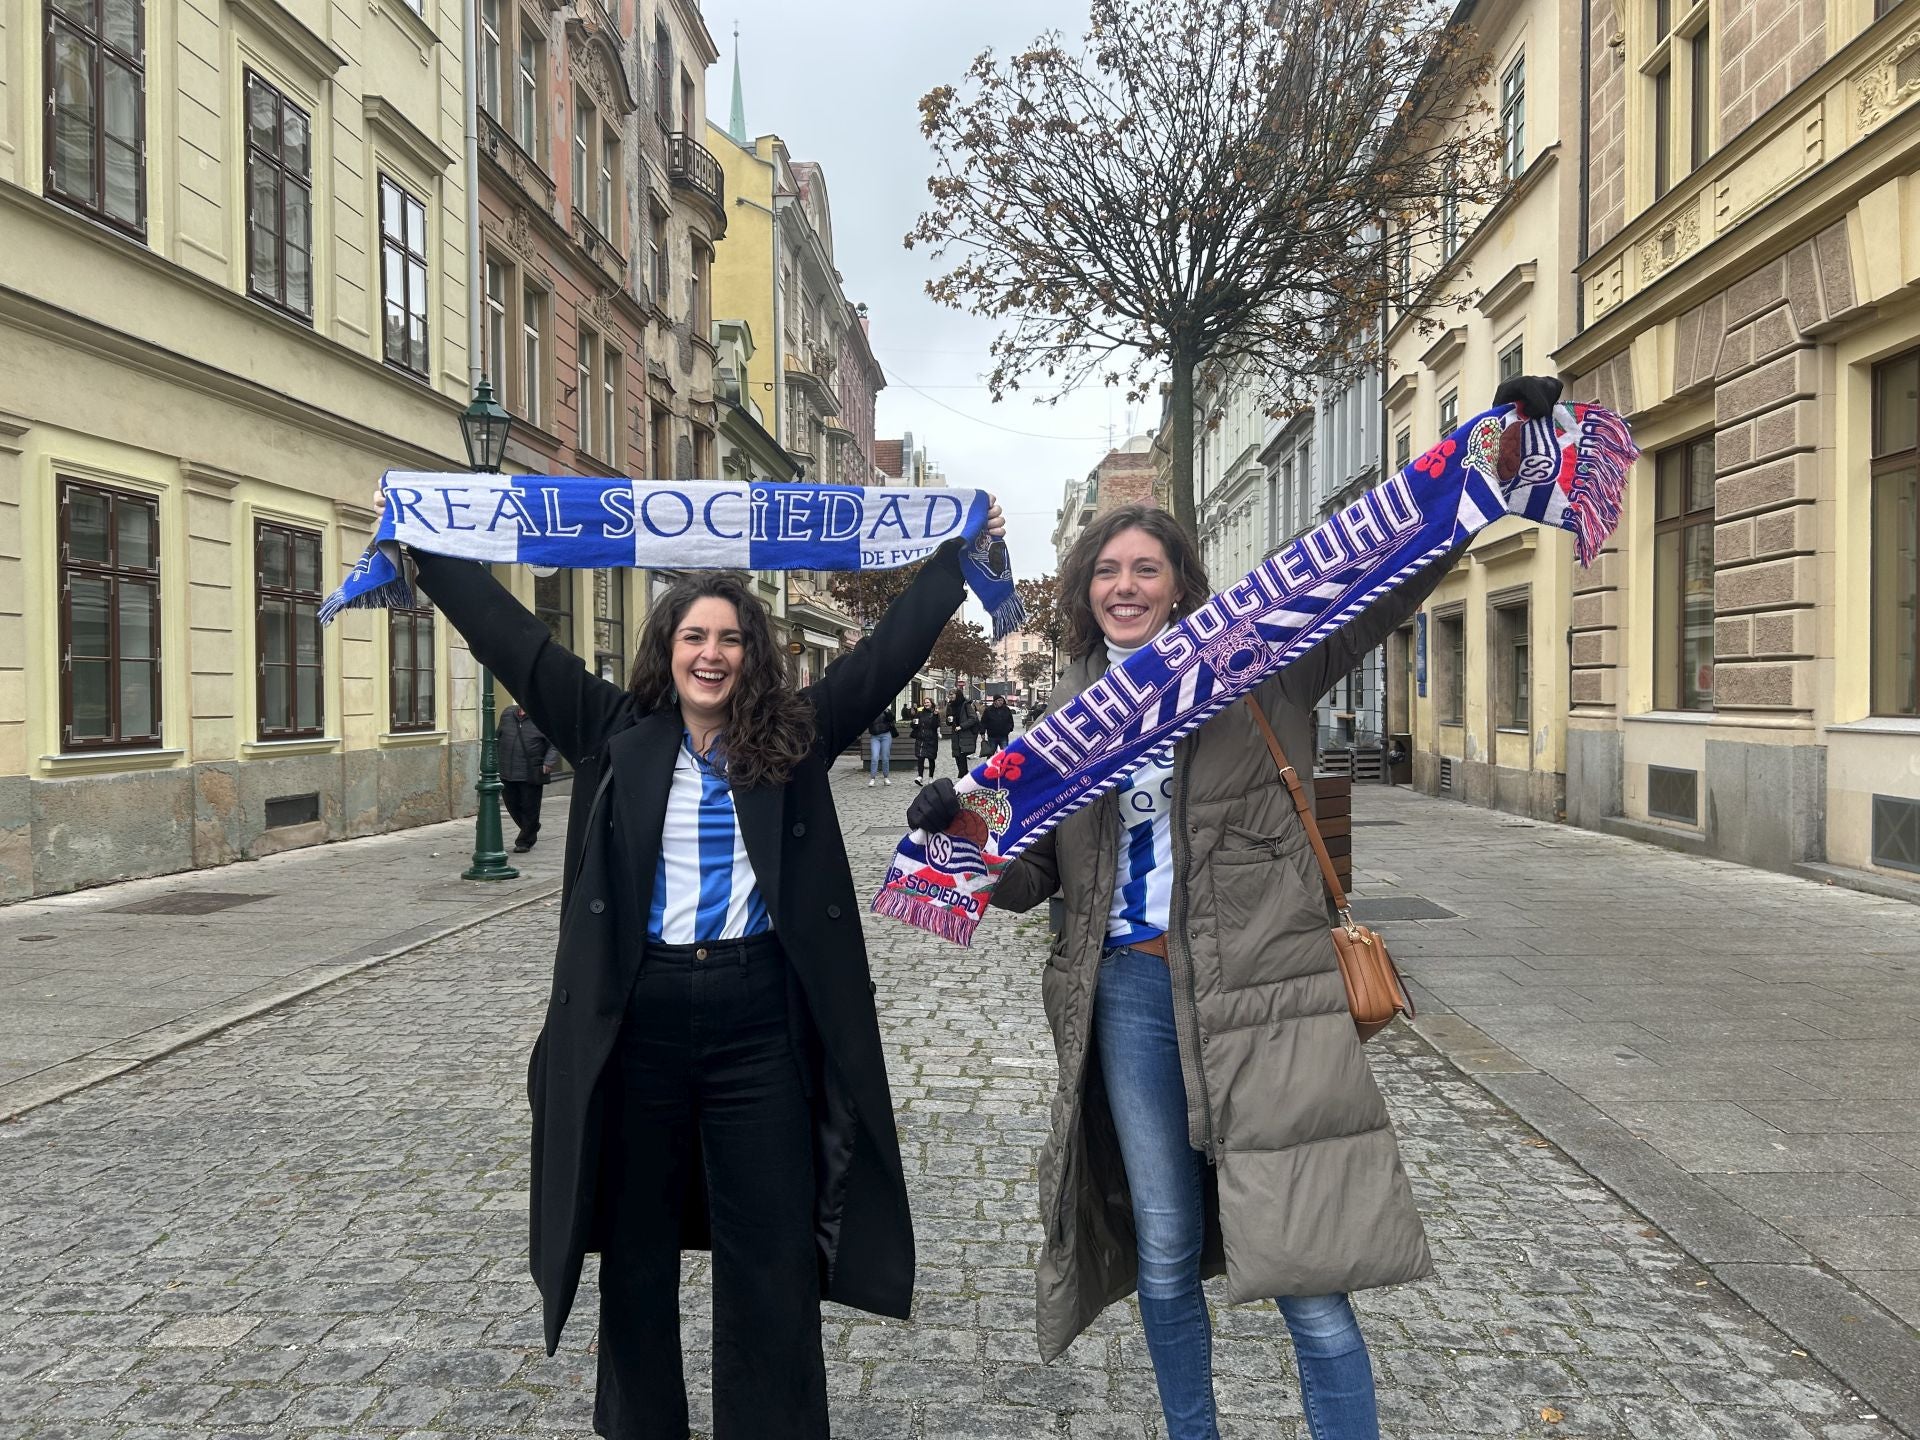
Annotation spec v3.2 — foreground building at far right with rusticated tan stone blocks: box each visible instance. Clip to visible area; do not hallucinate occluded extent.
[1557,0,1920,885]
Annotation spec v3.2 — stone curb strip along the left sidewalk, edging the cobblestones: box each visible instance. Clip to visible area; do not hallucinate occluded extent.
[0,879,561,1125]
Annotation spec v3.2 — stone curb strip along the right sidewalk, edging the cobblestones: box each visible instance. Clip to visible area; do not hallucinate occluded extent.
[1409,993,1920,1436]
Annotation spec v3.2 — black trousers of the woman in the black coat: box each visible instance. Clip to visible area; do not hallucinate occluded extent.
[593,935,828,1440]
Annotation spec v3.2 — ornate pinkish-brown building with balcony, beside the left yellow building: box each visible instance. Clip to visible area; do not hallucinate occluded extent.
[478,0,728,680]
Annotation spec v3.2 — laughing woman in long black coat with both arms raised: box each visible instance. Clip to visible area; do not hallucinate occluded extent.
[399,507,1002,1440]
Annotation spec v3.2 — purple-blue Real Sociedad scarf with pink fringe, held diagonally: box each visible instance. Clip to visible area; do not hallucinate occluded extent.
[874,405,1640,945]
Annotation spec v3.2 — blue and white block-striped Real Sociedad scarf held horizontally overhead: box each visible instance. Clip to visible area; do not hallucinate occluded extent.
[321,470,1025,639]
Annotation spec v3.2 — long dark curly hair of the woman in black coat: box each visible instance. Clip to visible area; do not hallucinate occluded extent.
[628,570,814,789]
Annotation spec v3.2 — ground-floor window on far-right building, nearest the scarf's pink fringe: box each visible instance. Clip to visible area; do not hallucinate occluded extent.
[1653,436,1713,710]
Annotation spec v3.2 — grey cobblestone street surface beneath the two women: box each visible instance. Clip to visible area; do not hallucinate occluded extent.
[0,774,1893,1440]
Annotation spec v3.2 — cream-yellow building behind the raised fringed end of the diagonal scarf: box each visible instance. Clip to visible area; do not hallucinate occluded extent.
[1382,0,1582,820]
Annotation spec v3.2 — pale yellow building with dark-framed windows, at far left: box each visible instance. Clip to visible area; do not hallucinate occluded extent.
[0,0,474,900]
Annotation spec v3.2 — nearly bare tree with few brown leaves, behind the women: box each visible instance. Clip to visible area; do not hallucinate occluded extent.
[906,0,1498,530]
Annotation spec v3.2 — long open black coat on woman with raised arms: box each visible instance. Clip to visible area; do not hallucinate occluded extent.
[415,545,964,1354]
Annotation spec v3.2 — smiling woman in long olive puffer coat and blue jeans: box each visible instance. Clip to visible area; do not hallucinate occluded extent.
[908,380,1559,1440]
